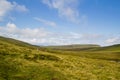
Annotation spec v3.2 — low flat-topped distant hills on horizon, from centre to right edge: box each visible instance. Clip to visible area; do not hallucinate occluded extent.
[46,44,120,52]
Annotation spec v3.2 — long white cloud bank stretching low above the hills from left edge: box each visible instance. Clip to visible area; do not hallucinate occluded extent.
[0,22,104,45]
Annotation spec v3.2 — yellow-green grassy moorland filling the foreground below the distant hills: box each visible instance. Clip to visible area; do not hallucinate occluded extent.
[0,36,120,80]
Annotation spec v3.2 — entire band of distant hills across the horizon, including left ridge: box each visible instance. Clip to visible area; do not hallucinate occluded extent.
[0,36,120,51]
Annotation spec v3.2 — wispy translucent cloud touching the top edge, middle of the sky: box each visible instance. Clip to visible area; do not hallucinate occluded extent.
[42,0,79,23]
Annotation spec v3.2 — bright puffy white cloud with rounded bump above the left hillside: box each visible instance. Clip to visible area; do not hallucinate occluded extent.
[0,22,48,38]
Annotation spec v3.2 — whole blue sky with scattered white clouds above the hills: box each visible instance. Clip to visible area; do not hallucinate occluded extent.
[0,0,120,46]
